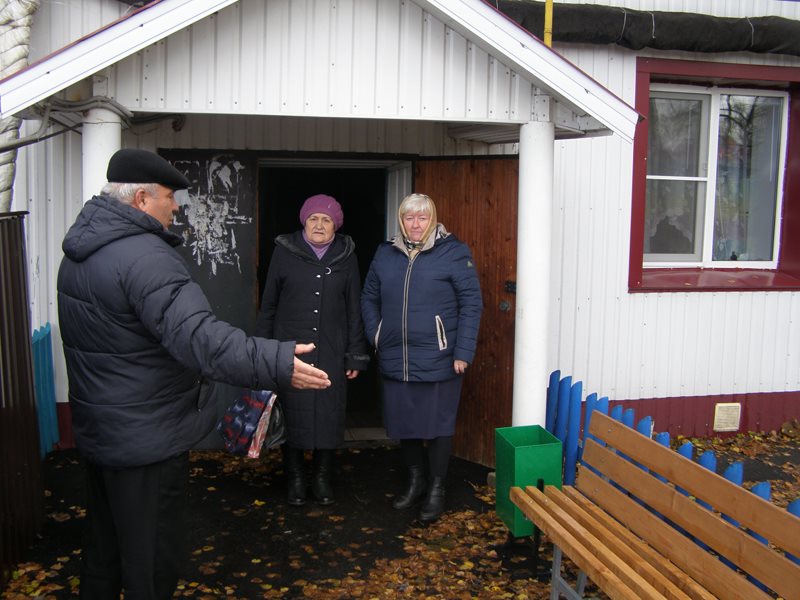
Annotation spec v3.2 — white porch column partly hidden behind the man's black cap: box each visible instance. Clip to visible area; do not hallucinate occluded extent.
[82,108,122,202]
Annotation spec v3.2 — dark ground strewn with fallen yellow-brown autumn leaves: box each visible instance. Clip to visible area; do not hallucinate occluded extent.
[2,423,800,600]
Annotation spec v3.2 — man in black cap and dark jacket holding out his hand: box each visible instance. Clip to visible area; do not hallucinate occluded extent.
[58,150,330,600]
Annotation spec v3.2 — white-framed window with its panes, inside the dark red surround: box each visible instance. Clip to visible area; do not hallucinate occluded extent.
[643,85,786,267]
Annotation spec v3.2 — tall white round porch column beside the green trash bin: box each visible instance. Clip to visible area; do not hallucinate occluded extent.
[511,121,555,426]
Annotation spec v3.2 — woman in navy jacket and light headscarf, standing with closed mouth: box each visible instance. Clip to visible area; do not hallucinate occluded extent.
[361,194,483,521]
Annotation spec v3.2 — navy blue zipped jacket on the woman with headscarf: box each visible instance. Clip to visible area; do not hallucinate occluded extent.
[361,224,483,381]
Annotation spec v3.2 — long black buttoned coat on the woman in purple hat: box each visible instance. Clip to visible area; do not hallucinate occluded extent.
[256,231,369,448]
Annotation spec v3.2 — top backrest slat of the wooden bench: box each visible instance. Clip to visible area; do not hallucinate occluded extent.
[589,411,800,556]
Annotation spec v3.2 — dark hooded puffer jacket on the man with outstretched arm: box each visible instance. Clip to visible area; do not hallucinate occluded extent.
[58,196,295,467]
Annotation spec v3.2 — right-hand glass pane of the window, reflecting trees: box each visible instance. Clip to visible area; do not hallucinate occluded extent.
[713,94,782,261]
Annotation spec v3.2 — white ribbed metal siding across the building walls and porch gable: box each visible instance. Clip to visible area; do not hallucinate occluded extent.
[12,0,800,408]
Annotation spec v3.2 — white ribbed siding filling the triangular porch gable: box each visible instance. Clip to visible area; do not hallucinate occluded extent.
[104,0,532,122]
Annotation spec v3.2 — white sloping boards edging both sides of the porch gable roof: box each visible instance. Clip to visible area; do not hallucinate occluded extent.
[0,0,638,140]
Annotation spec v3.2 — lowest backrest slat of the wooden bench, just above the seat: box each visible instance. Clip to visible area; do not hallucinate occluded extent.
[577,468,771,600]
